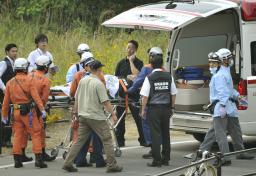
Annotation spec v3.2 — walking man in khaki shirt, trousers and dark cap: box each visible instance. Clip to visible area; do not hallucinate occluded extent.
[63,61,122,172]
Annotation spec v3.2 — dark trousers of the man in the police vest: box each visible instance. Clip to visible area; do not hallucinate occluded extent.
[148,106,171,162]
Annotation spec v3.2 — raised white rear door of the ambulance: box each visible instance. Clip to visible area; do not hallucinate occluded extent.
[102,0,238,31]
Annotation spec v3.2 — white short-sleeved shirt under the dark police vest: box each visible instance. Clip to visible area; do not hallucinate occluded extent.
[140,69,178,97]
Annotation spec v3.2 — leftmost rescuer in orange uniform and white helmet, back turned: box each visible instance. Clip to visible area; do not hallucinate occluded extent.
[2,58,47,168]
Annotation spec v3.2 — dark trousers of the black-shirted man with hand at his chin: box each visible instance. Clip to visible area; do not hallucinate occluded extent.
[116,105,145,146]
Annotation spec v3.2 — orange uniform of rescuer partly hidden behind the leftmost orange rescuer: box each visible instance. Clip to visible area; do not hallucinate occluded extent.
[22,70,51,148]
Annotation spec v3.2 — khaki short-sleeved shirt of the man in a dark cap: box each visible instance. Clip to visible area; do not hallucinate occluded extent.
[75,74,109,120]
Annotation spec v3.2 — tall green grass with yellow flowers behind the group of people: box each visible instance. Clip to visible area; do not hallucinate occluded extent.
[0,17,169,85]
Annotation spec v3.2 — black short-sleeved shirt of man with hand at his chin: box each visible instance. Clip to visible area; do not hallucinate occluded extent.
[115,57,143,78]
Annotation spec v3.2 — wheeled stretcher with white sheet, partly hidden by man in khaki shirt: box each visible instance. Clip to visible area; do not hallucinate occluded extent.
[48,76,140,159]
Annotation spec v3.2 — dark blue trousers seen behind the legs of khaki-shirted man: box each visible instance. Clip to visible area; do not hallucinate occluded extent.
[74,132,105,167]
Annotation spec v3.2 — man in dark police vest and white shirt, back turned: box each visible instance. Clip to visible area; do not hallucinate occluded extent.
[140,55,177,167]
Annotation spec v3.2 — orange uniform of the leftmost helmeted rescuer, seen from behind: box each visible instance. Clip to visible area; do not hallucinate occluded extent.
[2,73,44,155]
